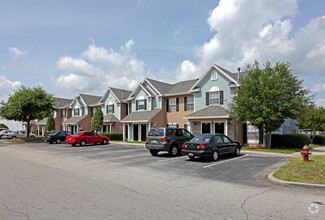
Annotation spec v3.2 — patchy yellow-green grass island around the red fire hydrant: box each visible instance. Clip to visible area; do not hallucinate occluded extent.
[274,155,325,184]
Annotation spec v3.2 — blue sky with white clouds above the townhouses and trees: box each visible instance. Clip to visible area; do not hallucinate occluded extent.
[0,0,325,106]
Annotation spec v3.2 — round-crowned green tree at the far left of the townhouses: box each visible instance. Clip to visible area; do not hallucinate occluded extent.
[0,86,55,137]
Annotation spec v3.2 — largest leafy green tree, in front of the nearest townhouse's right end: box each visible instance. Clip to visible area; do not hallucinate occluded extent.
[230,61,311,148]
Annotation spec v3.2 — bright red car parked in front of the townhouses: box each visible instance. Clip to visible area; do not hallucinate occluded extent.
[65,131,109,146]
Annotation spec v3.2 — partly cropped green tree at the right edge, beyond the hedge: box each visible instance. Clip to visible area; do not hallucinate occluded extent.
[299,104,325,143]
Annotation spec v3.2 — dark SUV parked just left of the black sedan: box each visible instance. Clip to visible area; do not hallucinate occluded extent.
[146,127,193,156]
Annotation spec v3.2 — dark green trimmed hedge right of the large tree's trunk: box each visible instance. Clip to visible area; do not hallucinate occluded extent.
[271,134,310,149]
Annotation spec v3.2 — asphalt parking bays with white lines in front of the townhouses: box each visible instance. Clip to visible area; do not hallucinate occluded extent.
[7,143,289,186]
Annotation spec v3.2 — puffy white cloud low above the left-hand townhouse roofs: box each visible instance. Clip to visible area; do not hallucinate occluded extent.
[55,39,145,95]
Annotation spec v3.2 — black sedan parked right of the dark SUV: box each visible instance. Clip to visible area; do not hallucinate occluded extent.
[182,134,241,161]
